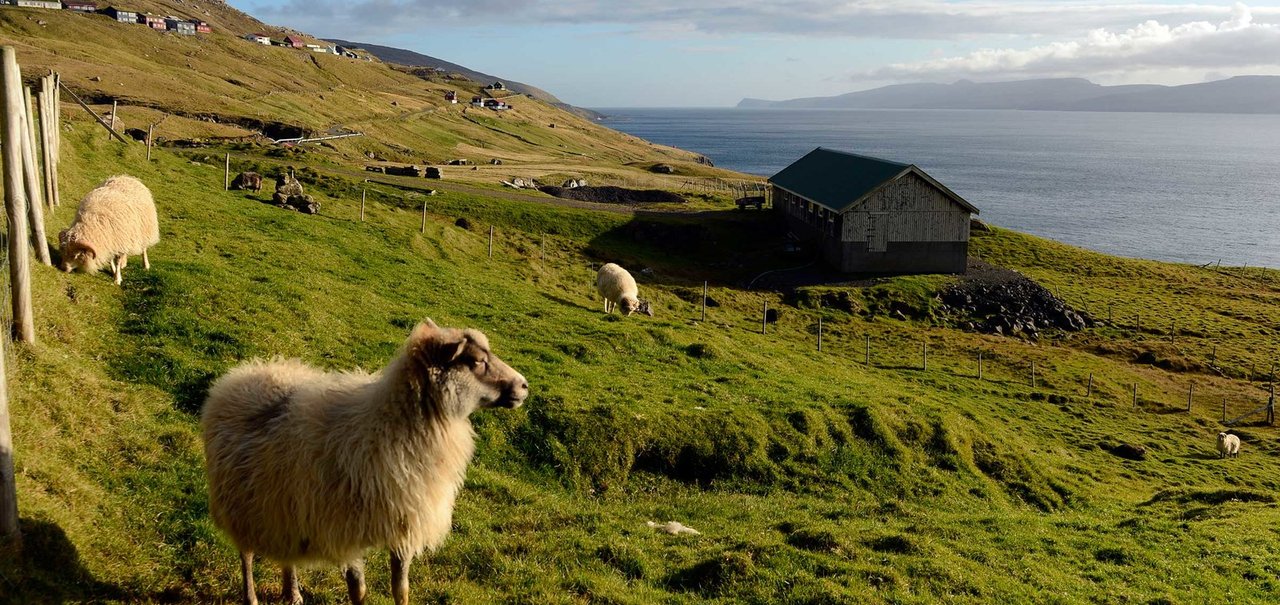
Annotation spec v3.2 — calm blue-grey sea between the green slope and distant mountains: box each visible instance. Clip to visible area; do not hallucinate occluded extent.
[600,109,1280,267]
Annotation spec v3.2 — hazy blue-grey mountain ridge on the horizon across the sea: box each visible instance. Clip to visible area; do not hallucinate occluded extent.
[737,75,1280,114]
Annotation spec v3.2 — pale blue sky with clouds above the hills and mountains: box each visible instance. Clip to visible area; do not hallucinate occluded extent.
[229,0,1280,107]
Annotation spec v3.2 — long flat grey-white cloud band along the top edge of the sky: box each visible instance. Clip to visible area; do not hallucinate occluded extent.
[236,0,1280,40]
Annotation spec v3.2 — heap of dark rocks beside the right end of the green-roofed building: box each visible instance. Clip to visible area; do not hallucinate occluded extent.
[940,275,1093,338]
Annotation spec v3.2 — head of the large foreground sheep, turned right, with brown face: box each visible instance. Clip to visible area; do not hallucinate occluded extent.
[410,320,529,417]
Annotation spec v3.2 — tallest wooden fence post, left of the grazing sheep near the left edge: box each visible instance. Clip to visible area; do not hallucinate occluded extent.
[0,46,36,343]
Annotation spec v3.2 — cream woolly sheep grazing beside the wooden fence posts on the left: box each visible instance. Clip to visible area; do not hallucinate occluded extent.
[58,174,160,285]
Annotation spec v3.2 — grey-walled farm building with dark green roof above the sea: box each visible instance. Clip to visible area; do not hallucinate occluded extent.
[769,147,978,274]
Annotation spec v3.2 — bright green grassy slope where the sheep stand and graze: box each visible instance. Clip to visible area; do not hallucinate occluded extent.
[0,103,1280,604]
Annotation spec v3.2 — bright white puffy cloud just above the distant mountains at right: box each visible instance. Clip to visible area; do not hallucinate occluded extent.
[855,4,1280,81]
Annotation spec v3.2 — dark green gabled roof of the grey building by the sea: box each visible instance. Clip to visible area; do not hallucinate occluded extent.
[769,147,978,214]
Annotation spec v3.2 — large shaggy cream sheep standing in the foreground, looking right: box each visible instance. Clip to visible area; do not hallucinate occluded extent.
[200,320,529,605]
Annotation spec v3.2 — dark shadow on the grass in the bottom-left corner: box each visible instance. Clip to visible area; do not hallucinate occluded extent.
[0,518,128,604]
